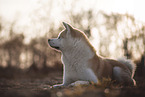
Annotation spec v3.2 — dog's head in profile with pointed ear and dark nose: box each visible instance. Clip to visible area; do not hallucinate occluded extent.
[48,22,89,52]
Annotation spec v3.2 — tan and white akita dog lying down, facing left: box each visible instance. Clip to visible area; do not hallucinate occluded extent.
[48,22,136,87]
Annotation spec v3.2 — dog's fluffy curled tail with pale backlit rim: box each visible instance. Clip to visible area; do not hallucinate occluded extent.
[118,58,136,77]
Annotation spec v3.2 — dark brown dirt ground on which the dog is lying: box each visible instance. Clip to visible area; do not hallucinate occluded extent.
[0,72,145,97]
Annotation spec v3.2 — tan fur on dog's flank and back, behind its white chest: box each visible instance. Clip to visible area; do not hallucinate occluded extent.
[89,55,128,80]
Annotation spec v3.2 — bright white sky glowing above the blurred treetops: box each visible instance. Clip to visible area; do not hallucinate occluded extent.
[0,0,145,22]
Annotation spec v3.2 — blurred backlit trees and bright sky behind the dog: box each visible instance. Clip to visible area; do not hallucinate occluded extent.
[0,0,145,78]
